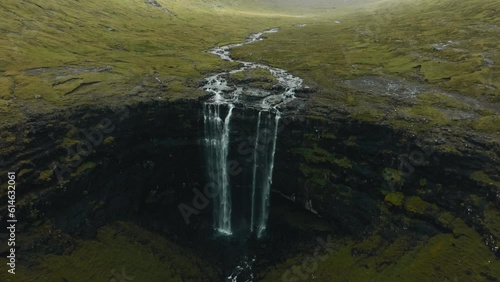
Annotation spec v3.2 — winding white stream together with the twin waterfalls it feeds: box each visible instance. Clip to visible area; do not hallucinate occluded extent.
[203,28,303,238]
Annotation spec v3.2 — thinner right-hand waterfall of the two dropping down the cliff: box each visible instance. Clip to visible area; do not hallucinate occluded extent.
[250,111,280,238]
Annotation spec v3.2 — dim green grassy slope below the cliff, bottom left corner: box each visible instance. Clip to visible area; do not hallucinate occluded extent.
[0,222,220,282]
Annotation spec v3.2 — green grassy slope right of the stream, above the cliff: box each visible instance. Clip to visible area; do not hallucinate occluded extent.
[234,0,500,138]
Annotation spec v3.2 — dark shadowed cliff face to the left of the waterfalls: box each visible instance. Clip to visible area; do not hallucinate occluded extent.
[3,102,203,239]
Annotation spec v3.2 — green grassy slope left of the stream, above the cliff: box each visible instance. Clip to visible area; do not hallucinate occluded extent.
[0,0,298,124]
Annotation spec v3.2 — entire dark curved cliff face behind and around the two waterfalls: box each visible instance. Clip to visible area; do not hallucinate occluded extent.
[4,101,500,280]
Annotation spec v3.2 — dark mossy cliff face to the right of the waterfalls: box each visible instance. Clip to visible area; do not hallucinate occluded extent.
[273,115,500,239]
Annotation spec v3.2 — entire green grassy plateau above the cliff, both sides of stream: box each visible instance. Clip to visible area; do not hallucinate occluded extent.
[0,0,500,138]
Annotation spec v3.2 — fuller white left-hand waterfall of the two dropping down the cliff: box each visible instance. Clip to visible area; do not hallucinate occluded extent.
[203,103,234,235]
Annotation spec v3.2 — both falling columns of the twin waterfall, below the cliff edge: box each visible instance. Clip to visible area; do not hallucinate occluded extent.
[203,107,280,238]
